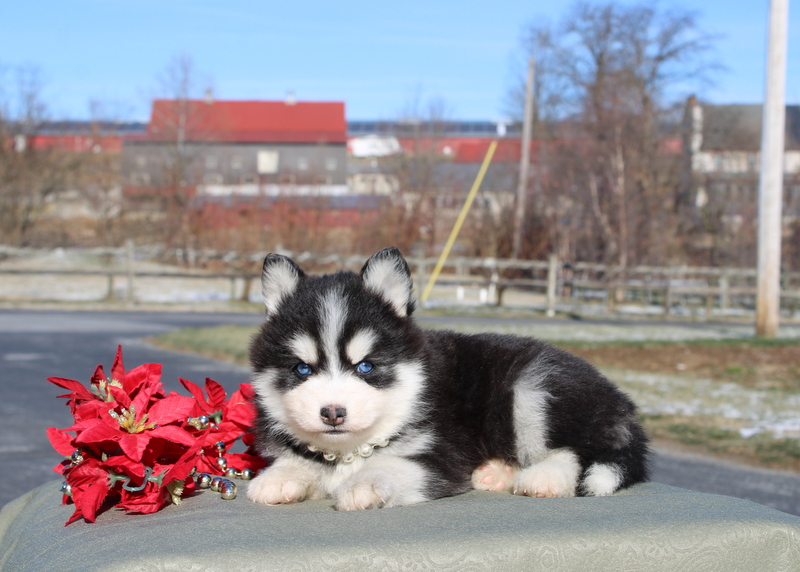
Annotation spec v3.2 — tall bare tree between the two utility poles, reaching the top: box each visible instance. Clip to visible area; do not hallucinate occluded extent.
[512,2,714,267]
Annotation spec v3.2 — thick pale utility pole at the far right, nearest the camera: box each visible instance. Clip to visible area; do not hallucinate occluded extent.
[756,0,789,338]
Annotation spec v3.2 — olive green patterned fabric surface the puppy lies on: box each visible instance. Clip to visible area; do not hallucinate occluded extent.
[0,482,800,572]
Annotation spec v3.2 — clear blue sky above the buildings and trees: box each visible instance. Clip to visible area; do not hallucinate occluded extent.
[0,0,800,120]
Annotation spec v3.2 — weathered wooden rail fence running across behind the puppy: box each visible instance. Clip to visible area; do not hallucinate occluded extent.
[0,243,800,315]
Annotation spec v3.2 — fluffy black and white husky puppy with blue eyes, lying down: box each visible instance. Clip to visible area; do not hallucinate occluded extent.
[247,248,648,510]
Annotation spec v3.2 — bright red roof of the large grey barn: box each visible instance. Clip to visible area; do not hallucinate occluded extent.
[147,99,347,143]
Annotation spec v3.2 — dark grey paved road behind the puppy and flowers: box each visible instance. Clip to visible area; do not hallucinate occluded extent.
[0,310,800,515]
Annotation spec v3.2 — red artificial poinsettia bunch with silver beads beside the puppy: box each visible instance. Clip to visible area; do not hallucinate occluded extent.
[47,346,265,524]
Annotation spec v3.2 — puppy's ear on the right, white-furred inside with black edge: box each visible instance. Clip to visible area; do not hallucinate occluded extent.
[361,246,414,318]
